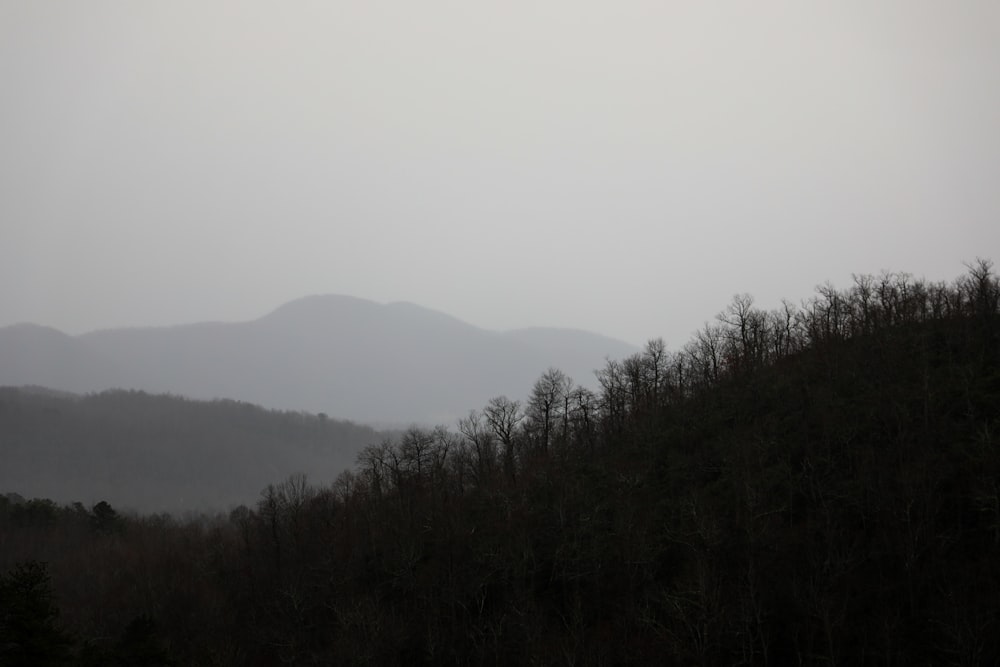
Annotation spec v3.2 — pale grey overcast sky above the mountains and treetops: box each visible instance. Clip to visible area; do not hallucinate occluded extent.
[0,0,1000,346]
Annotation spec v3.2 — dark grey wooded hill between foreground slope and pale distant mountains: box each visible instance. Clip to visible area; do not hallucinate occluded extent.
[0,387,382,513]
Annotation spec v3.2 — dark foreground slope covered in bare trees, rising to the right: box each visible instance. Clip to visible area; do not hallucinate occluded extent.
[0,261,1000,665]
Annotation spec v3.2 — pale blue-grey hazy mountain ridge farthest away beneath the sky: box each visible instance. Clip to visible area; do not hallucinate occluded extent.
[0,295,636,424]
